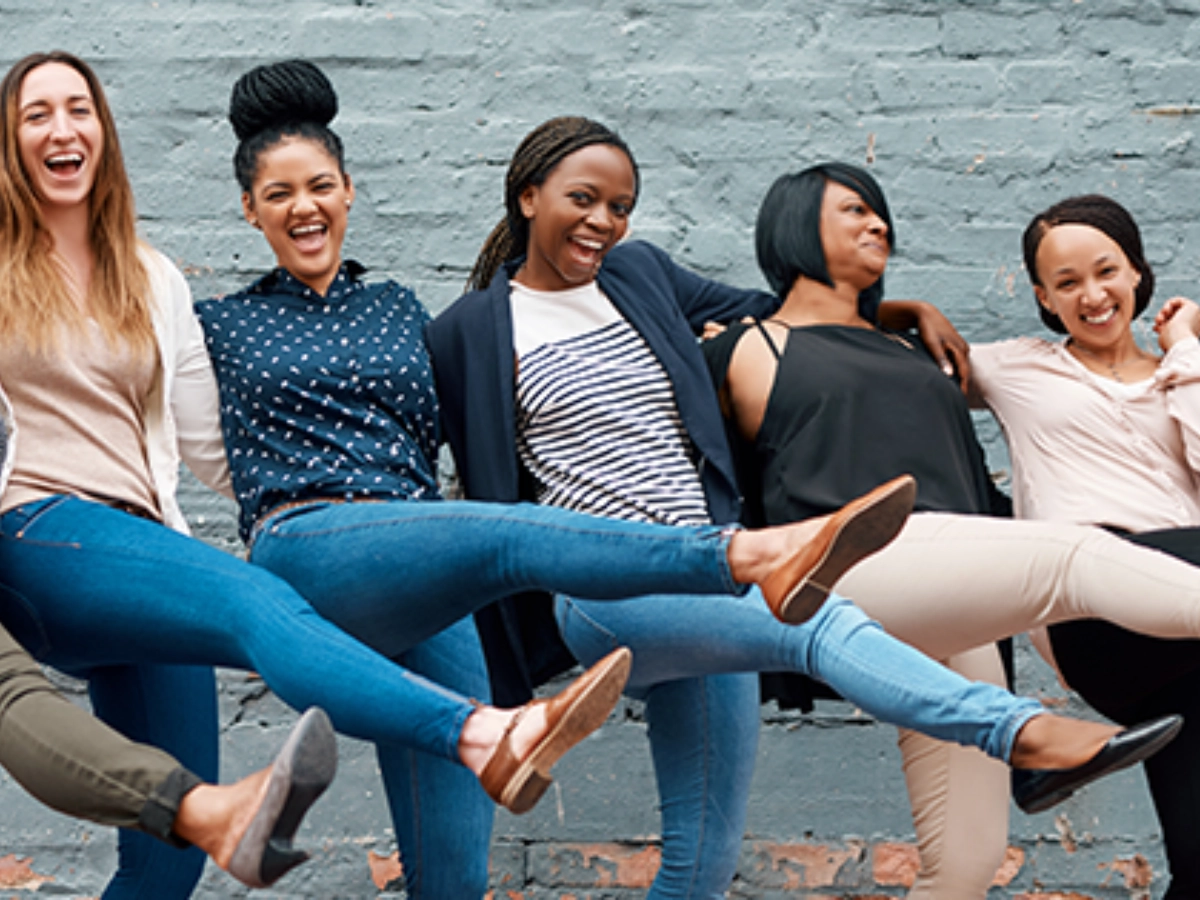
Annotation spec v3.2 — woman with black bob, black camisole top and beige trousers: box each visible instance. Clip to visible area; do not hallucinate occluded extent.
[704,164,1200,900]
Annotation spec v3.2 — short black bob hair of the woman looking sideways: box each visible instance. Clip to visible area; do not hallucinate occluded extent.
[755,162,895,323]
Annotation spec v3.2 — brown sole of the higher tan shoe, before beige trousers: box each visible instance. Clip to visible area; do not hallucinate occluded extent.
[776,476,917,625]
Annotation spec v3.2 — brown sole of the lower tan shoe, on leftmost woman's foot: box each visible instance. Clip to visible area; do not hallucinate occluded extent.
[500,647,634,815]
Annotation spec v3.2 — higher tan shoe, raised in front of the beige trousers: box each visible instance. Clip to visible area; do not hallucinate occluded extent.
[760,475,917,625]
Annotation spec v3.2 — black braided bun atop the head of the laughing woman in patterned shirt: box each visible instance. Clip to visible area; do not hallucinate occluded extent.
[229,59,337,140]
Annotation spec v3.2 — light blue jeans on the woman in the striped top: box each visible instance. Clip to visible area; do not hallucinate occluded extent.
[556,590,1044,900]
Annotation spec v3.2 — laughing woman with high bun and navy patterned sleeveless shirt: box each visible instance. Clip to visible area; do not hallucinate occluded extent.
[197,60,907,900]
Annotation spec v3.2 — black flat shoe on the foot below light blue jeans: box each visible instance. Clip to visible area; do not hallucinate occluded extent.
[1013,715,1183,814]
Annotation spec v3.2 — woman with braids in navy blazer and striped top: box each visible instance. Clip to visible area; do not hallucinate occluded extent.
[427,118,1178,900]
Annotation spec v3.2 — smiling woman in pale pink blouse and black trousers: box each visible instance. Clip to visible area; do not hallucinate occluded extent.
[971,194,1200,900]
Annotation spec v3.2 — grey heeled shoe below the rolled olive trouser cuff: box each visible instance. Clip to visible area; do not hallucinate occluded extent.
[229,707,337,888]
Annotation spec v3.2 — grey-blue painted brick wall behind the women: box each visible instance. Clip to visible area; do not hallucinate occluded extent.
[0,0,1200,900]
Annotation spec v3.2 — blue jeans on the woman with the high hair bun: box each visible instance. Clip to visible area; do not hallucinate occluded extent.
[243,502,736,900]
